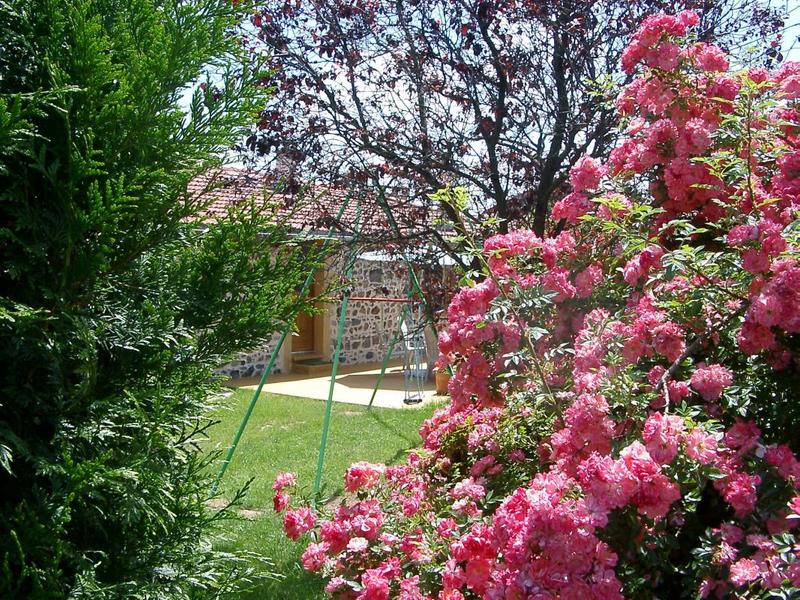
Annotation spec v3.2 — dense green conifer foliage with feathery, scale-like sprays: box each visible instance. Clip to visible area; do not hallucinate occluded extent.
[0,0,312,599]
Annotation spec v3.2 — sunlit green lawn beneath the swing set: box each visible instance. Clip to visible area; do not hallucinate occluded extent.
[210,390,434,600]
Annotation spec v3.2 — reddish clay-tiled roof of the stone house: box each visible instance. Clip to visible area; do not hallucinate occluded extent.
[188,167,432,240]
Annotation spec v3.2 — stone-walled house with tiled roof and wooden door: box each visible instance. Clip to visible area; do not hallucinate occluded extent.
[189,168,438,378]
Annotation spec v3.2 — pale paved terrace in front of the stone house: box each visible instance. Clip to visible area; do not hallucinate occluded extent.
[229,364,442,408]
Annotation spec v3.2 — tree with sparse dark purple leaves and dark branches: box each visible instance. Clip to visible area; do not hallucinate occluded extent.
[246,0,783,248]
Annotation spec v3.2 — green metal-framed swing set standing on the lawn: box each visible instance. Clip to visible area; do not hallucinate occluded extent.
[210,185,427,506]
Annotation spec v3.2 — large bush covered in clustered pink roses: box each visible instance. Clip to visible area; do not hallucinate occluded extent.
[275,12,800,600]
